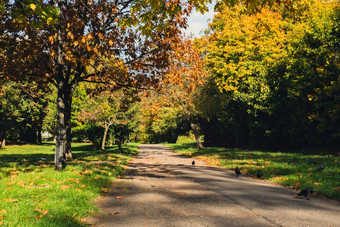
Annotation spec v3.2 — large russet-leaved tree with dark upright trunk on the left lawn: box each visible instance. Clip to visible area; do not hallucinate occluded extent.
[0,0,210,169]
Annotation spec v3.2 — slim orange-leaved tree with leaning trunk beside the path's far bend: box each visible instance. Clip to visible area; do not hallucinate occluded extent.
[160,39,207,149]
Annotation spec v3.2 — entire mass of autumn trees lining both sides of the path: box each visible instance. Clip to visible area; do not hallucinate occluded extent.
[0,0,340,169]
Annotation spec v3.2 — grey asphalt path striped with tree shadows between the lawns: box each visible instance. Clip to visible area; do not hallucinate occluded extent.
[87,144,340,227]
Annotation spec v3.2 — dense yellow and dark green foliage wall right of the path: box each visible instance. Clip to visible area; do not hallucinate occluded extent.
[196,1,340,152]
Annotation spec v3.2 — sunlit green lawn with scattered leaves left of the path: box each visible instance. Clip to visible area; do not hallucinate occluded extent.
[0,143,138,227]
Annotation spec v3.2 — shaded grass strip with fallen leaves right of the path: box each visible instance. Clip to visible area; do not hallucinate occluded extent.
[167,137,340,201]
